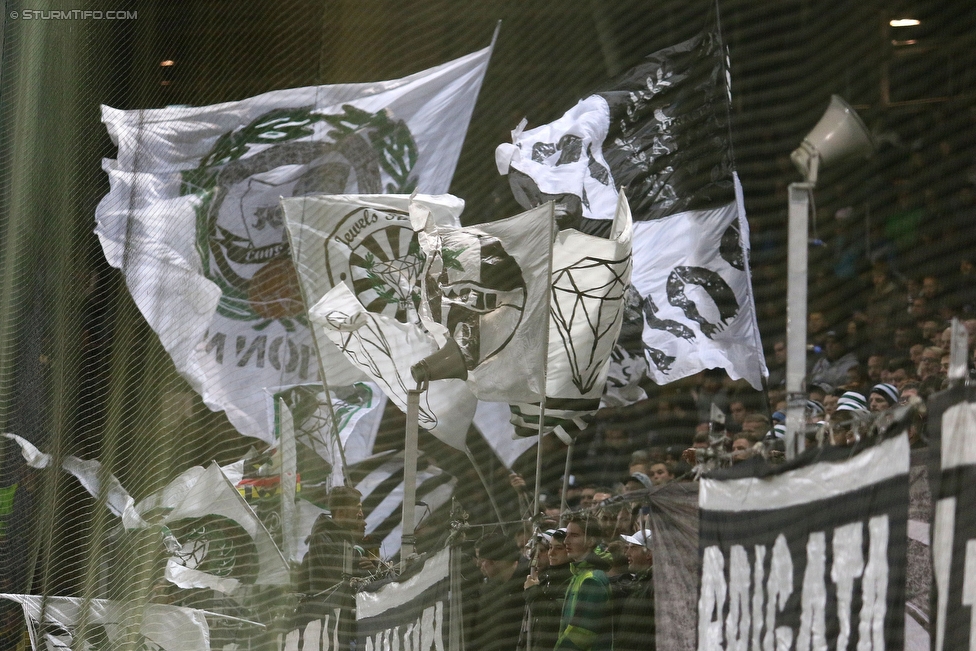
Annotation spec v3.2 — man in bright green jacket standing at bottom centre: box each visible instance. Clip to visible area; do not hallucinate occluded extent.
[553,513,613,651]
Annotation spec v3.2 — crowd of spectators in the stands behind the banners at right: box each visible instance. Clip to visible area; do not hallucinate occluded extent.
[465,259,976,649]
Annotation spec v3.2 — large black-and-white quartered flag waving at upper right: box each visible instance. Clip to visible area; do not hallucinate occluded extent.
[495,17,767,389]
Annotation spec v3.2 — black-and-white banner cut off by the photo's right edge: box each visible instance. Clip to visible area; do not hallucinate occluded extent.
[929,387,976,651]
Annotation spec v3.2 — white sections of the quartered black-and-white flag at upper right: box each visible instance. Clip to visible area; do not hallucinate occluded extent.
[495,95,768,395]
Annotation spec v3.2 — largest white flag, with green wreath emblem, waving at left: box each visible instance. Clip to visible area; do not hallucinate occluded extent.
[96,48,490,442]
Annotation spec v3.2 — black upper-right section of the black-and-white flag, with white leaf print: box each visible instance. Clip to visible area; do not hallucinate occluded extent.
[599,23,735,221]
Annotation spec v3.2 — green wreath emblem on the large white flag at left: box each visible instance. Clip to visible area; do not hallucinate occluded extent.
[181,105,417,331]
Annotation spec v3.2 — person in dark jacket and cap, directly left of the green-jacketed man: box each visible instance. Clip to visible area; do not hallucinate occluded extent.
[519,527,572,649]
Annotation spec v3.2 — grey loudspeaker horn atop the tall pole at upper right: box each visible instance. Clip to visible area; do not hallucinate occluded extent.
[790,95,874,183]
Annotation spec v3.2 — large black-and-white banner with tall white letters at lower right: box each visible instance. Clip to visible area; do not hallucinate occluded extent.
[698,434,912,651]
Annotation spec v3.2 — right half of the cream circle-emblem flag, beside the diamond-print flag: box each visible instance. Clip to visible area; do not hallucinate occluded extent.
[411,203,555,402]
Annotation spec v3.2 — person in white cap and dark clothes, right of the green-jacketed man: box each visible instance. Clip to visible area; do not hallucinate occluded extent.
[613,529,656,651]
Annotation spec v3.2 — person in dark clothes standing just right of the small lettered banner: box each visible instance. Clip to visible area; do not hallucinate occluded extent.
[471,534,525,651]
